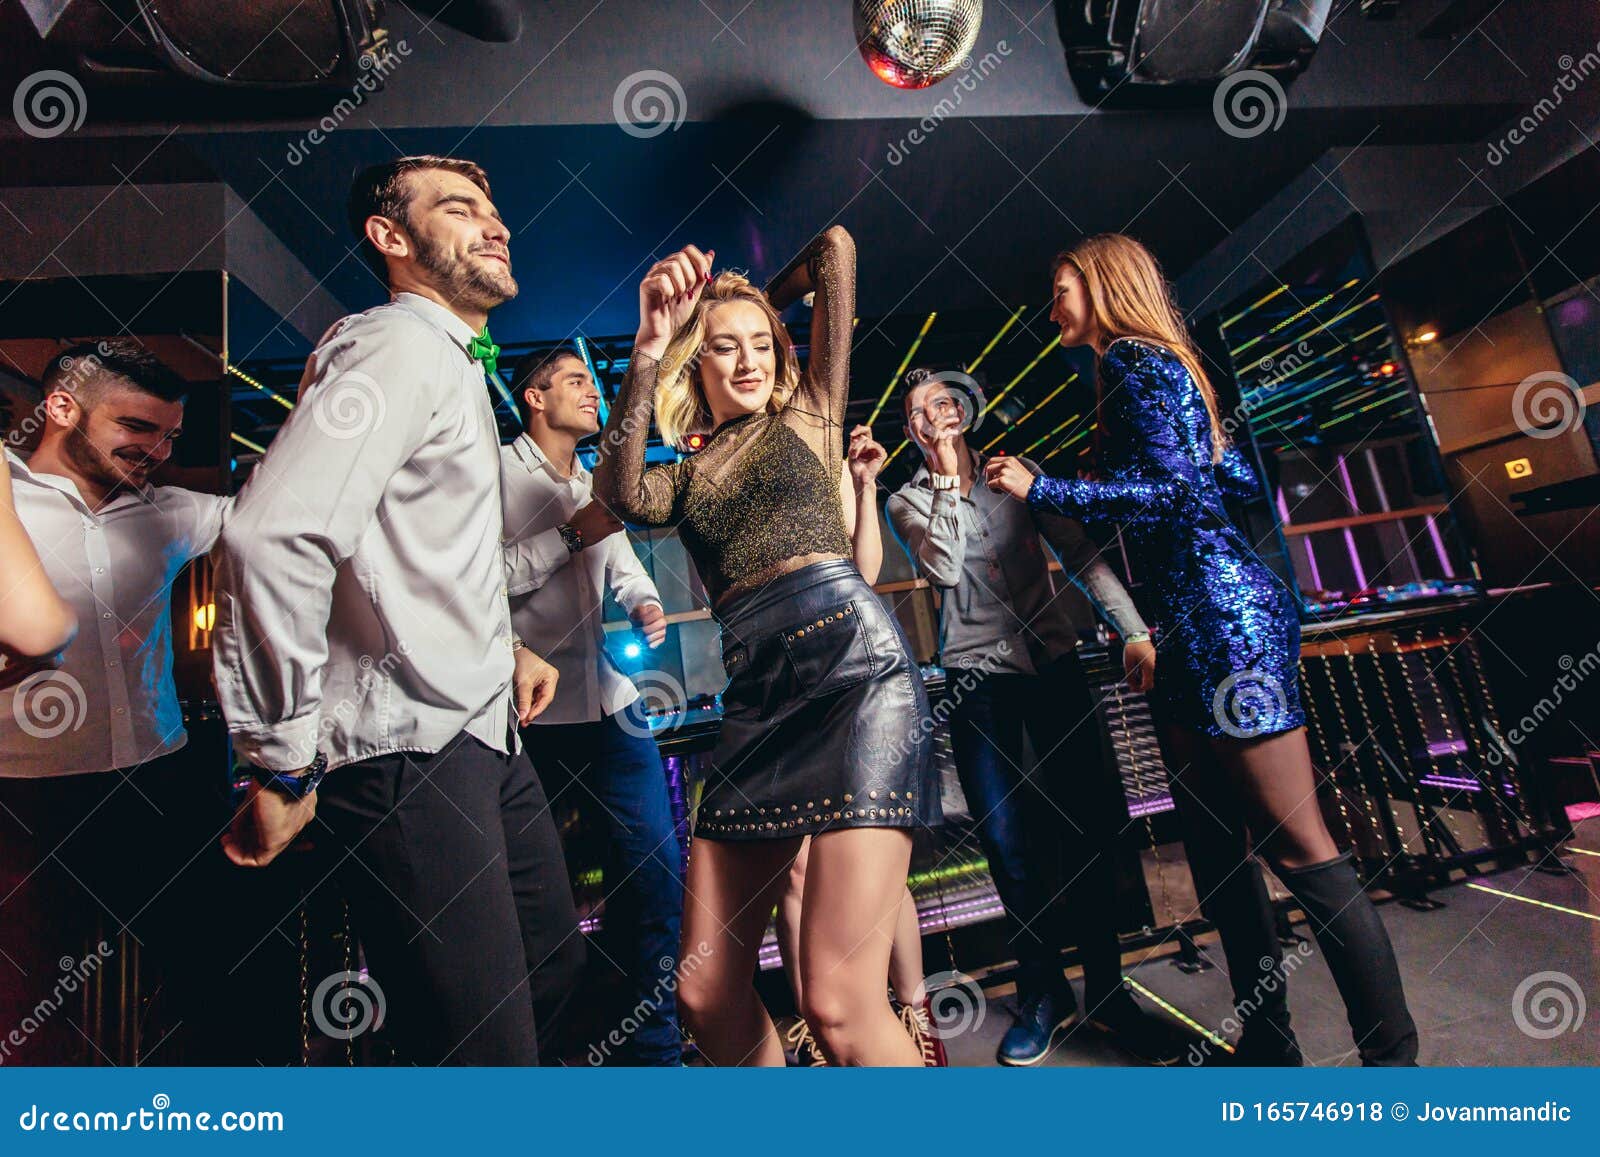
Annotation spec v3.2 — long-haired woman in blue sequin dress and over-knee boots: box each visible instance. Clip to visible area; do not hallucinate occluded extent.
[986,234,1418,1064]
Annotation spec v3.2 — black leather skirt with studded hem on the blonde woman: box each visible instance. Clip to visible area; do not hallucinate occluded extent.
[694,558,941,840]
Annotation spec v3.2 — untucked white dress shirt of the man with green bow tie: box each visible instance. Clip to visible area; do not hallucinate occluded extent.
[214,293,518,771]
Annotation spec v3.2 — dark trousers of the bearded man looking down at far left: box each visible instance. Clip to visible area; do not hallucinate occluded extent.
[0,747,236,1064]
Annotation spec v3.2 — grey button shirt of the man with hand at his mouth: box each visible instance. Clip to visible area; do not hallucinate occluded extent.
[888,450,1146,674]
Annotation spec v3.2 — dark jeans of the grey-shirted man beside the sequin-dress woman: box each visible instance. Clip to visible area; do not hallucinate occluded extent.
[944,653,1128,1010]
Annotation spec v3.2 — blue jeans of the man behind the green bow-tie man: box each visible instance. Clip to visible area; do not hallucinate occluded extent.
[522,703,683,1064]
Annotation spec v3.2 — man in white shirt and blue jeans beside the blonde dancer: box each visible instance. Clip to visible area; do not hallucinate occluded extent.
[501,350,683,1066]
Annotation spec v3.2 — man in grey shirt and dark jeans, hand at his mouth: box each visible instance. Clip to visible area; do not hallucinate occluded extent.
[888,370,1184,1064]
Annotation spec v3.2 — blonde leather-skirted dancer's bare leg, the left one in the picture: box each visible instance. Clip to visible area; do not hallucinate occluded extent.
[678,839,800,1067]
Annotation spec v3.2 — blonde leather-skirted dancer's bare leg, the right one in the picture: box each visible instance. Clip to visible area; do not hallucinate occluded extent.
[800,827,923,1067]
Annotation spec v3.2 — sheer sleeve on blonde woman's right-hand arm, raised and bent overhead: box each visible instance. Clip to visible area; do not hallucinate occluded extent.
[766,226,856,478]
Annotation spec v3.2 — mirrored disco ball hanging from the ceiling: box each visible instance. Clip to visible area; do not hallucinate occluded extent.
[856,0,984,88]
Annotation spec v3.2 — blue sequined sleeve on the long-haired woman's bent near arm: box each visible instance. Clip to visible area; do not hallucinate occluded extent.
[1027,342,1197,526]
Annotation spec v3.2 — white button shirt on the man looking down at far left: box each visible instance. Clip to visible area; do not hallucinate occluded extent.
[0,450,234,778]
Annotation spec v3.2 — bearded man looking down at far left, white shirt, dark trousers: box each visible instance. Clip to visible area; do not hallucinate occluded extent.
[0,339,234,1064]
